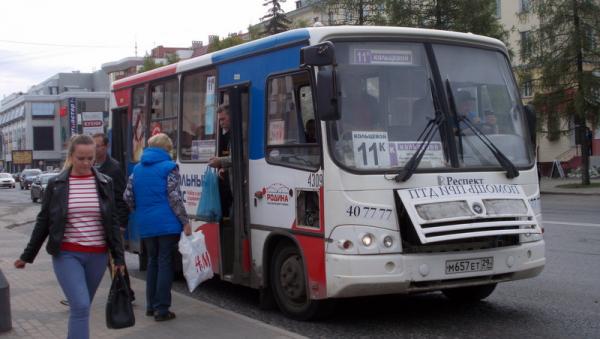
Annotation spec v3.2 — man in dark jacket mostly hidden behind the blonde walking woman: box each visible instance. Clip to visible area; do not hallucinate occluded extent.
[93,133,135,299]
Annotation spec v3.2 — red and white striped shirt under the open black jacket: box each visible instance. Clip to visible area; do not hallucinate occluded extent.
[61,175,106,252]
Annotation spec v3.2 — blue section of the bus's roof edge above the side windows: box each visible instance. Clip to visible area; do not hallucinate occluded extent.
[212,29,310,63]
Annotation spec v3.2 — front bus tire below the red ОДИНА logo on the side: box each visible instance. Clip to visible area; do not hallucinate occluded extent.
[270,242,333,320]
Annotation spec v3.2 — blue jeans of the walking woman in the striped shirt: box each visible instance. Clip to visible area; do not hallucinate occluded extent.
[52,251,108,339]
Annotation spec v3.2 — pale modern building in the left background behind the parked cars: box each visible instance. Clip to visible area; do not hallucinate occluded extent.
[0,71,109,172]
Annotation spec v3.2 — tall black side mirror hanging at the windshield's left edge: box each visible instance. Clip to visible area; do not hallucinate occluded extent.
[316,67,340,121]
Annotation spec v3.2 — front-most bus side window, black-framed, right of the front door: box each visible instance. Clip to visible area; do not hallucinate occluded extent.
[266,71,321,171]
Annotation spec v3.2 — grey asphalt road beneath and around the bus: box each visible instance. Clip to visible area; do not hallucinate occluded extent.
[0,188,600,338]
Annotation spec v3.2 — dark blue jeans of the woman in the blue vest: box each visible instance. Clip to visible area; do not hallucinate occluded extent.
[144,234,179,315]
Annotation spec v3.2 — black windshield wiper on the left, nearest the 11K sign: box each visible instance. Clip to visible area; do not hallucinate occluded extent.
[394,78,444,182]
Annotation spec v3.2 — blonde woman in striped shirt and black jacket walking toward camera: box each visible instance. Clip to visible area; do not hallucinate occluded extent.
[14,135,124,339]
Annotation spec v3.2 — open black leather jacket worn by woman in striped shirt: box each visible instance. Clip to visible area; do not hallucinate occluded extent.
[20,168,125,265]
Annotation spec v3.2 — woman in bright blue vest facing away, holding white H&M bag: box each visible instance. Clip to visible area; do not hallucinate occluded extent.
[124,133,192,321]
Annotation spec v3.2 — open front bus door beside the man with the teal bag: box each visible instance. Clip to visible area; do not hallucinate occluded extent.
[219,84,250,285]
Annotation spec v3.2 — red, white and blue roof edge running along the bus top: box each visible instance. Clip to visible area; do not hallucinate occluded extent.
[112,26,506,90]
